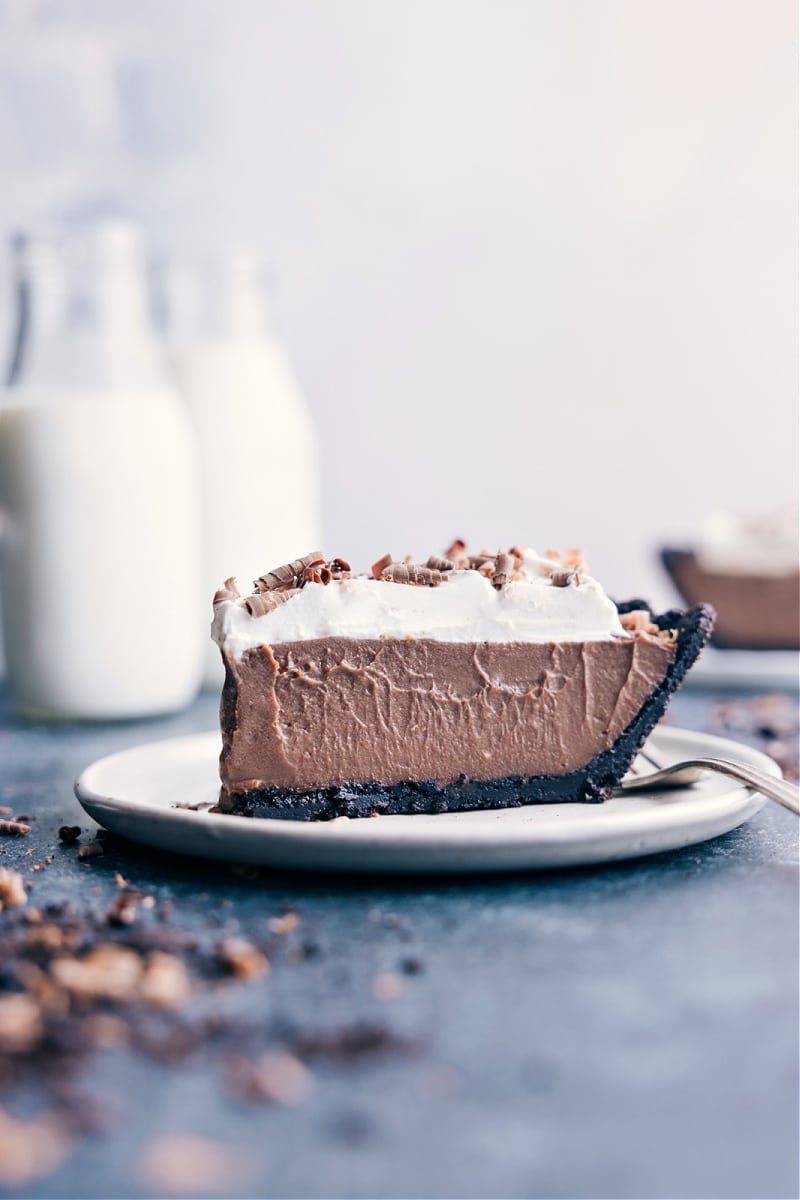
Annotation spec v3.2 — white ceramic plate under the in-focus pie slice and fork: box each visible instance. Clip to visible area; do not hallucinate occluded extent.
[76,726,781,872]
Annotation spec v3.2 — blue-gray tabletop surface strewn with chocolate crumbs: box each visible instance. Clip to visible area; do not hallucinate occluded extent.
[0,691,799,1200]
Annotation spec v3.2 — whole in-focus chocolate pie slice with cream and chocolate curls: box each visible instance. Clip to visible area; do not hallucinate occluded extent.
[212,542,714,820]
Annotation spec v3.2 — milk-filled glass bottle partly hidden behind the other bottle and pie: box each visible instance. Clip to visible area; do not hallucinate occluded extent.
[167,254,320,686]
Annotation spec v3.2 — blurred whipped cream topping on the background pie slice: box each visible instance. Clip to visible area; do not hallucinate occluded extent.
[694,509,800,577]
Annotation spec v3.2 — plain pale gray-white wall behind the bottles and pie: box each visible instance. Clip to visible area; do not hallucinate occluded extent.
[0,0,798,599]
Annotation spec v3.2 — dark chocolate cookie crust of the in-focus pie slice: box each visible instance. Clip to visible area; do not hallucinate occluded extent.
[217,600,715,821]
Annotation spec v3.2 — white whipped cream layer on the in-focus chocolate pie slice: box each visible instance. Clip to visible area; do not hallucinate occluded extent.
[211,550,630,659]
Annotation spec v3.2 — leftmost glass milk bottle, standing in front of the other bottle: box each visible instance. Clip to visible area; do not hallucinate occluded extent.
[0,224,210,720]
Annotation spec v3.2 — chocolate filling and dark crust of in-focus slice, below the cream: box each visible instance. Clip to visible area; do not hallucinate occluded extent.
[219,606,712,818]
